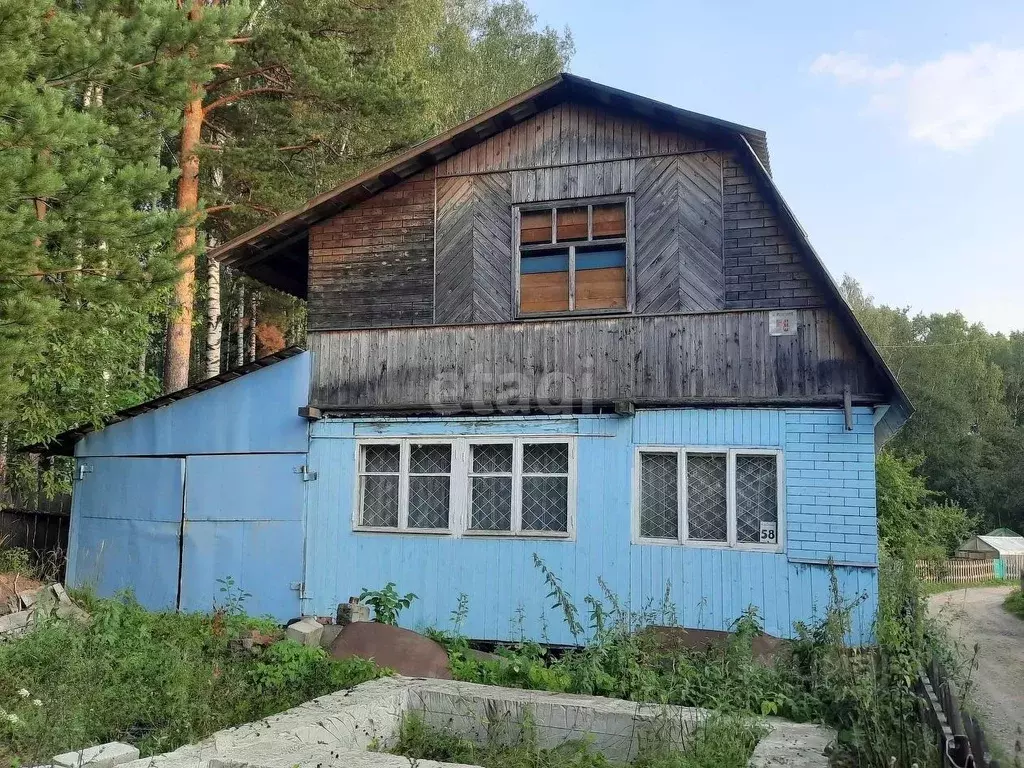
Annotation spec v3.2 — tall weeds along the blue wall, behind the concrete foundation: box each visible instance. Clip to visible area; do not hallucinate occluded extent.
[431,559,932,768]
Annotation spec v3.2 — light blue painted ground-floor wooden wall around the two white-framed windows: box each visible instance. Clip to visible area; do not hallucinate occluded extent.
[303,409,878,643]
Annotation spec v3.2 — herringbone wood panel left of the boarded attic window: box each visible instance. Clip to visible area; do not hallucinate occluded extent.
[434,173,512,323]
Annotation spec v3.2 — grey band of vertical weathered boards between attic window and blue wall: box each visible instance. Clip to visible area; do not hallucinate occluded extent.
[310,309,881,410]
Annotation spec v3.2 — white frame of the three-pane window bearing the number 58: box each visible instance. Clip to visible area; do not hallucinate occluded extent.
[632,445,785,553]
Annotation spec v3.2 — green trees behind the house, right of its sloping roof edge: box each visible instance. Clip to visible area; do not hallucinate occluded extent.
[843,275,1024,529]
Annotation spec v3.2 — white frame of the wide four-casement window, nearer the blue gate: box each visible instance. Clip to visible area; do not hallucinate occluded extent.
[352,435,577,541]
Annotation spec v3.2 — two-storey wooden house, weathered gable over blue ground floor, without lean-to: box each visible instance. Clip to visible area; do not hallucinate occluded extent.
[39,75,910,642]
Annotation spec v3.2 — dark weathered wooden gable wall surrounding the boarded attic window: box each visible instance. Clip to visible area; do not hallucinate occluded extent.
[309,103,825,330]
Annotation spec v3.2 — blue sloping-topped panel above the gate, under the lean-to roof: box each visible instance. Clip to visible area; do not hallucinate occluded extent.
[75,352,309,457]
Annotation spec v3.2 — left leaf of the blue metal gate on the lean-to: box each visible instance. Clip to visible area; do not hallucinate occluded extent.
[68,458,185,610]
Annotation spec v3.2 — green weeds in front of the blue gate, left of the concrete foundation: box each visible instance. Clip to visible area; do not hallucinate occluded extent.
[0,596,381,765]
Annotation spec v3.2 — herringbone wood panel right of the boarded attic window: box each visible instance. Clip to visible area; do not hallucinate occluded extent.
[634,153,725,313]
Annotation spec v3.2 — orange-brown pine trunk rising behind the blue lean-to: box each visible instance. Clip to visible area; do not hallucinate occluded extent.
[164,0,204,392]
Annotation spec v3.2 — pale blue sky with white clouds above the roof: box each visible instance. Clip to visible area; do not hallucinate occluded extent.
[527,0,1024,333]
